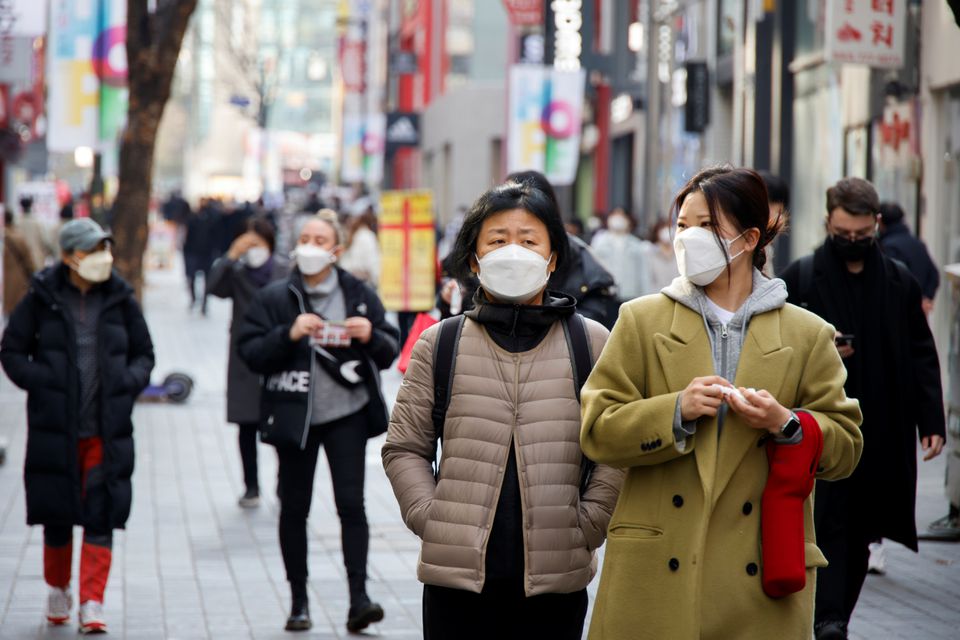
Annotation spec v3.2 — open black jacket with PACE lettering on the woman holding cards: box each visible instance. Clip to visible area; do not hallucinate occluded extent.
[237,268,400,448]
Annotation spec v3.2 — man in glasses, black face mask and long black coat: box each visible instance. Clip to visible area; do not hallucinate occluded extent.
[782,178,945,640]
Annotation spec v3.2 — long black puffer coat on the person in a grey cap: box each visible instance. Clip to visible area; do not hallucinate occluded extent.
[0,265,154,528]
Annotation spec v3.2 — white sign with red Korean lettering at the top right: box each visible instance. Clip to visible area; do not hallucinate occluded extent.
[826,0,907,69]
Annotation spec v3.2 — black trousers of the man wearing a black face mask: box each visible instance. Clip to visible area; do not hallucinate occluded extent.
[814,480,877,623]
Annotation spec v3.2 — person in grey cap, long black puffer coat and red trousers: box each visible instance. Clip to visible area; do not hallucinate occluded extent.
[0,218,154,633]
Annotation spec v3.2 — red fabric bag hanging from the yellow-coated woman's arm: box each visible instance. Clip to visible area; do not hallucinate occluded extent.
[760,411,823,598]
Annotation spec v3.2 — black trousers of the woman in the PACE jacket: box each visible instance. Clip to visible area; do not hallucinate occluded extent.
[277,411,370,600]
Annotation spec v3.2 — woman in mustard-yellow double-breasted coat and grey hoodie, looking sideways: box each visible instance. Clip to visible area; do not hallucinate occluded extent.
[581,168,862,640]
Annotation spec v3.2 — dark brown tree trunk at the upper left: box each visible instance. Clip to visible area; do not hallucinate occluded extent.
[112,0,197,298]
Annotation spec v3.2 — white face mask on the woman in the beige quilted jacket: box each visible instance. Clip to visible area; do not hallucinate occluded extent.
[477,244,550,304]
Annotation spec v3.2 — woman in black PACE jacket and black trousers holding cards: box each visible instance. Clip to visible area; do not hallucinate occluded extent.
[237,209,399,633]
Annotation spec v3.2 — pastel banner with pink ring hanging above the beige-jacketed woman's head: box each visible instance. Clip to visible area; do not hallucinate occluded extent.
[507,64,586,186]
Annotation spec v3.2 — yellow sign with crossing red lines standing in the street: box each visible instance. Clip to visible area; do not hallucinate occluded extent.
[379,190,437,311]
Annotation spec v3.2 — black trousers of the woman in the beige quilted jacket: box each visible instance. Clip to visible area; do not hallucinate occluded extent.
[423,581,587,640]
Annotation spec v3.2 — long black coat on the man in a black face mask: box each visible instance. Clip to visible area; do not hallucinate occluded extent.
[782,244,945,550]
